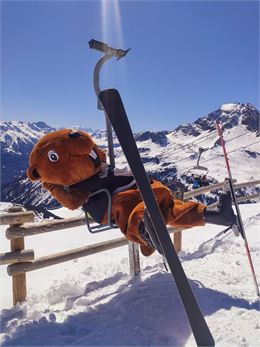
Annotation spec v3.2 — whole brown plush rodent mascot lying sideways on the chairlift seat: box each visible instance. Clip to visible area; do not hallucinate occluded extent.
[27,129,235,256]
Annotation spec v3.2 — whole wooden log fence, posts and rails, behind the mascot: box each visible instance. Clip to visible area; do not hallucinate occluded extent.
[0,180,260,305]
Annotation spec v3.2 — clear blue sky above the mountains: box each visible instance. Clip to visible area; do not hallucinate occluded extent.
[1,0,259,131]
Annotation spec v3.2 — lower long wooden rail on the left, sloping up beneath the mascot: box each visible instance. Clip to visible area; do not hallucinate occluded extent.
[7,237,128,276]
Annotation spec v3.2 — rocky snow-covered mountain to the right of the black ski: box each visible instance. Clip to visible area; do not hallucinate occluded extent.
[133,103,260,185]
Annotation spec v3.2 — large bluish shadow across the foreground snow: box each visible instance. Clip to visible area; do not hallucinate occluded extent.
[2,272,257,346]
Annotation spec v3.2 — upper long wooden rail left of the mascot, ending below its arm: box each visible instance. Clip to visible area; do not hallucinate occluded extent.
[6,216,87,240]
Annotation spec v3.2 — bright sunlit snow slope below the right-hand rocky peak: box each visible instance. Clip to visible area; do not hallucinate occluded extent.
[160,124,260,182]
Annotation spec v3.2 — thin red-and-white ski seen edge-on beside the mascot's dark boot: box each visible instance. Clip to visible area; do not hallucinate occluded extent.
[216,122,260,297]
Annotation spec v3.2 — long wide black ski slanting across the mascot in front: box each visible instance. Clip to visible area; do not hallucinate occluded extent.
[99,89,215,346]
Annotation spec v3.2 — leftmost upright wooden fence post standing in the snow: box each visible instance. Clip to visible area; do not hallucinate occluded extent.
[8,206,26,305]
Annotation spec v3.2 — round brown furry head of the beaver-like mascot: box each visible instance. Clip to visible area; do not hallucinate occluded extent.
[27,129,106,186]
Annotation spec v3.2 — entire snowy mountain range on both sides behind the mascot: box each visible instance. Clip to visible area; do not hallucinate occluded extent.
[0,103,260,205]
